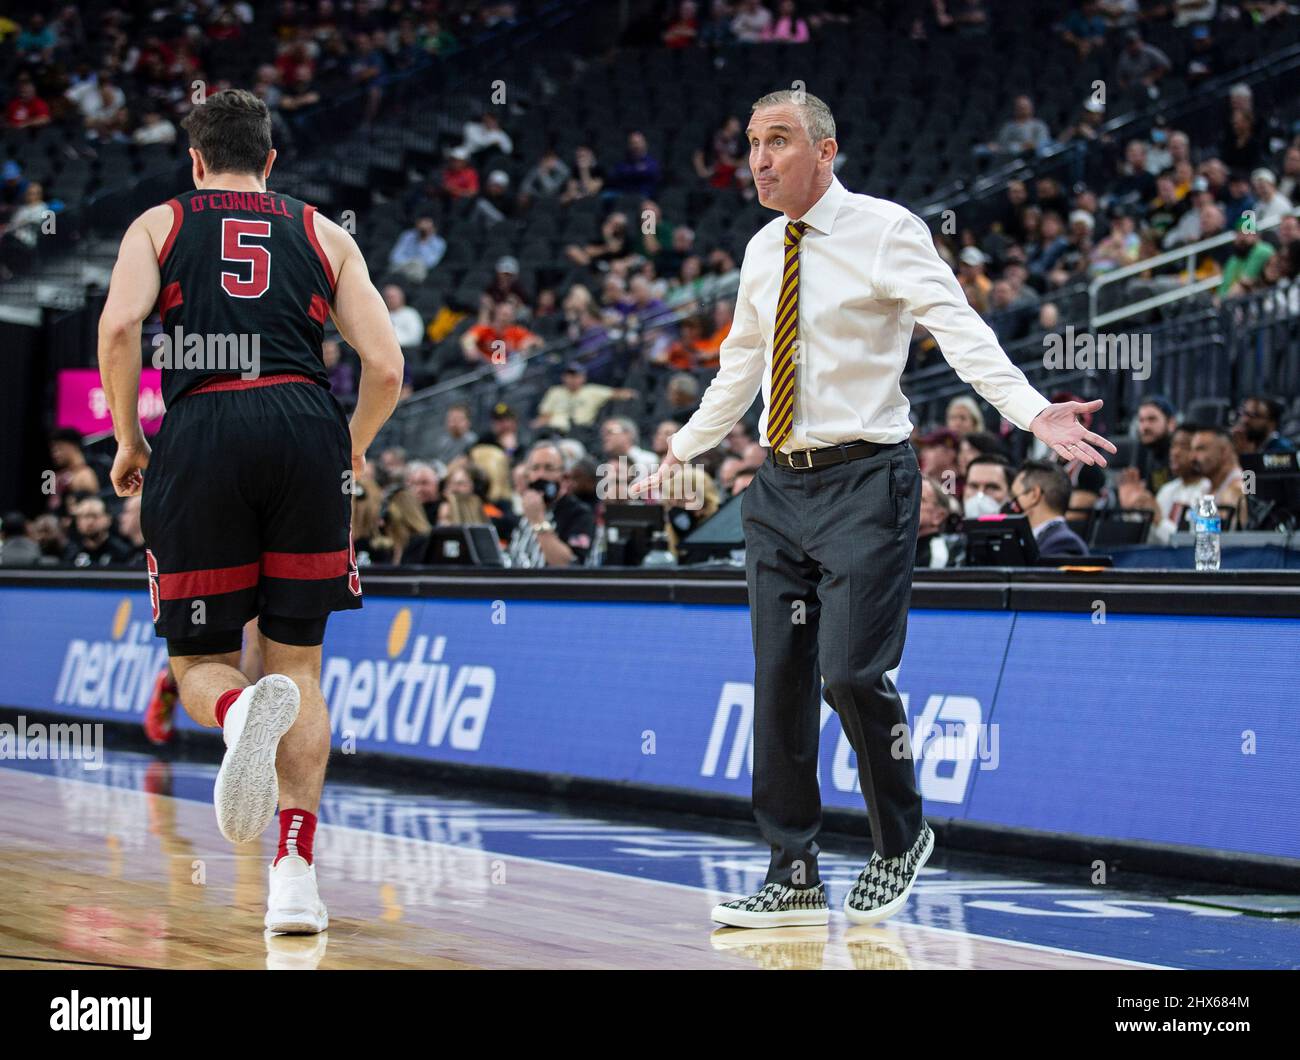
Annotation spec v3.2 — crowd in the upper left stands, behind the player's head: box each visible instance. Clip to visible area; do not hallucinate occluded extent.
[0,0,523,269]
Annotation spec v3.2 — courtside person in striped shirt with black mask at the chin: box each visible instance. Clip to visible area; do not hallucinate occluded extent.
[508,442,595,567]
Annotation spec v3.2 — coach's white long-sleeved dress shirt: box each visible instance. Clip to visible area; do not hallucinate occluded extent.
[672,177,1049,460]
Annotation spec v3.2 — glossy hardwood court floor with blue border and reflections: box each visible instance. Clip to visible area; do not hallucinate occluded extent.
[0,752,1300,969]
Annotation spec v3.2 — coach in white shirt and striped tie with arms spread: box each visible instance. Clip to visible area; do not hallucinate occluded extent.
[634,91,1115,927]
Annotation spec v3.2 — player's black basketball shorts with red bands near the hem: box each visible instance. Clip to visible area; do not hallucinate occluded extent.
[140,376,361,640]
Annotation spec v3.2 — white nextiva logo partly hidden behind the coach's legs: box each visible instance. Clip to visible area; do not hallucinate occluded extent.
[699,675,998,804]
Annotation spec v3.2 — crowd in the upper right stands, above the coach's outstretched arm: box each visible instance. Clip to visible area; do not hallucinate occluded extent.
[935,10,1300,353]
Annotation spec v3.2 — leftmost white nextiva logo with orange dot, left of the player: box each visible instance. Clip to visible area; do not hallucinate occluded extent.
[55,598,166,714]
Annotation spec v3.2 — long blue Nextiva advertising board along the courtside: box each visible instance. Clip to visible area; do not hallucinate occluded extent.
[0,588,1300,857]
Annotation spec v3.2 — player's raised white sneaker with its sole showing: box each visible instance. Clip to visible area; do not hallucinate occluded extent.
[212,674,298,843]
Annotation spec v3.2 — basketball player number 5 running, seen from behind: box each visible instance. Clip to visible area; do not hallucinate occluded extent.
[99,90,402,933]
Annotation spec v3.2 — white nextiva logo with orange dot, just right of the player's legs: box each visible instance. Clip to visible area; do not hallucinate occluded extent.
[321,607,497,750]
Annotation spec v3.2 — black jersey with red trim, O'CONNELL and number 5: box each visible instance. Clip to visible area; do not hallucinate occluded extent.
[147,189,335,406]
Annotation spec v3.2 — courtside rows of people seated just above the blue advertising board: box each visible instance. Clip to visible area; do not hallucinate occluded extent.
[0,384,1296,567]
